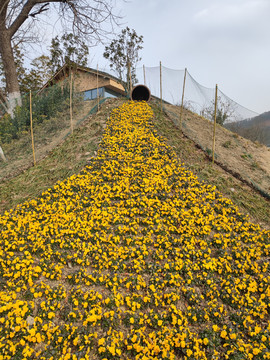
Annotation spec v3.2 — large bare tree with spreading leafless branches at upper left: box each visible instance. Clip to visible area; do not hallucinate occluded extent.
[0,0,120,113]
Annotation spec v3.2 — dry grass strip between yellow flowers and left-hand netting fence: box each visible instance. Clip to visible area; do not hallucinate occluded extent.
[0,100,126,213]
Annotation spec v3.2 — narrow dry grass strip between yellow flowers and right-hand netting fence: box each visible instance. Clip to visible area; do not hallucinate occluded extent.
[153,105,270,225]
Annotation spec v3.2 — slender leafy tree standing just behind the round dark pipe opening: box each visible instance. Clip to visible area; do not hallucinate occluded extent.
[103,27,143,91]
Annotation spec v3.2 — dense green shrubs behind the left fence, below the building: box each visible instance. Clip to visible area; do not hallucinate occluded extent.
[0,85,69,143]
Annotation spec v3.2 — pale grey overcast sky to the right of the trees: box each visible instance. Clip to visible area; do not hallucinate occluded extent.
[92,0,270,113]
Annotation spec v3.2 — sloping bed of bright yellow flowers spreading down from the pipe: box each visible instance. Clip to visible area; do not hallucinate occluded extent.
[0,102,270,360]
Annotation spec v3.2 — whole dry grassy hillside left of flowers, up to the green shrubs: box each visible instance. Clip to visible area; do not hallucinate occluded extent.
[0,100,123,212]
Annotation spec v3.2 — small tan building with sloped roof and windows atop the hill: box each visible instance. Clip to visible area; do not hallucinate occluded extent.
[39,63,126,100]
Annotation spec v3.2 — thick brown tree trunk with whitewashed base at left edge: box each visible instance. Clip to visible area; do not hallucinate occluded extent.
[0,28,22,115]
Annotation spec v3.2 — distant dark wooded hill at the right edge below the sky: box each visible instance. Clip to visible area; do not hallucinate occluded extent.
[225,111,270,147]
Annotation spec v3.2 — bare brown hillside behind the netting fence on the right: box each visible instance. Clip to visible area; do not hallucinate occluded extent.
[162,105,270,198]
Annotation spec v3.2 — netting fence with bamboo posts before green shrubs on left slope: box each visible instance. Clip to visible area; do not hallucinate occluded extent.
[0,79,103,182]
